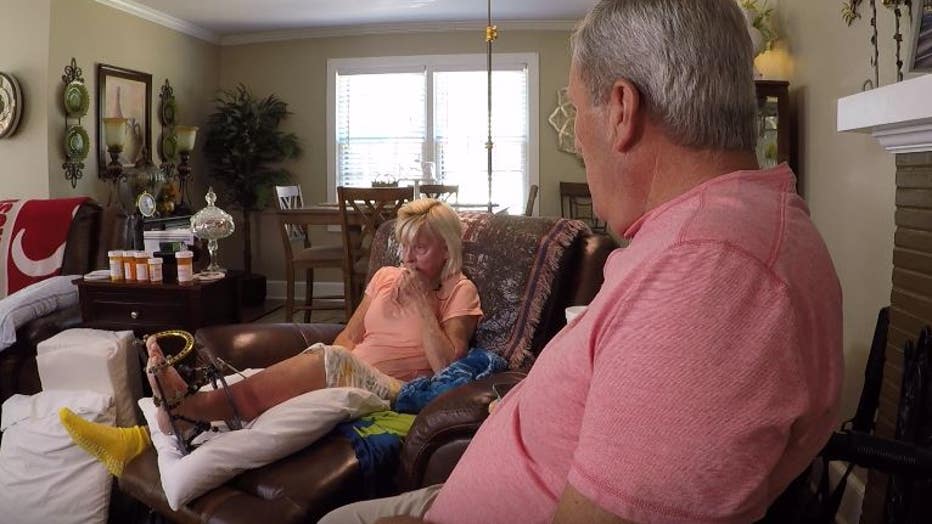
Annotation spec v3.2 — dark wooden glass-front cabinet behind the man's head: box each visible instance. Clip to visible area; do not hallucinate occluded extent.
[754,80,799,176]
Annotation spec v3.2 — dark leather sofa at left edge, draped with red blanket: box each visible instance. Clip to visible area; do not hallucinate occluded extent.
[0,201,131,422]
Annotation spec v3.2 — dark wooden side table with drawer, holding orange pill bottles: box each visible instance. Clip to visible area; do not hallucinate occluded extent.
[76,278,239,335]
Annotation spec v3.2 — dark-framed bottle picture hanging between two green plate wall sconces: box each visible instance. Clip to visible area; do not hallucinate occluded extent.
[97,64,152,176]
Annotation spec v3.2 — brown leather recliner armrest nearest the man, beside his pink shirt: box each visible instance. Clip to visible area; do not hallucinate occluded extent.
[398,371,526,489]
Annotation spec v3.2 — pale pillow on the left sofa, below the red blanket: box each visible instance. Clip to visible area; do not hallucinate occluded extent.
[0,275,78,351]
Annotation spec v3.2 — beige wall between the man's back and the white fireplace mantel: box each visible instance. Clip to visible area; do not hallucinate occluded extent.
[779,0,909,416]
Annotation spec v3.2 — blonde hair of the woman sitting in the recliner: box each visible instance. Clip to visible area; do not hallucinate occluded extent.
[395,198,463,279]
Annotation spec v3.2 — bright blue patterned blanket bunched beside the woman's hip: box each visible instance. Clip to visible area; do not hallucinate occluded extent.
[394,348,508,413]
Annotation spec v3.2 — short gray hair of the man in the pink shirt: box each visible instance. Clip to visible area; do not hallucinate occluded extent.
[572,0,757,150]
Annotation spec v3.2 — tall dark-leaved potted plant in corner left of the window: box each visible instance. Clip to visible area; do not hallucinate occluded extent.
[204,84,301,305]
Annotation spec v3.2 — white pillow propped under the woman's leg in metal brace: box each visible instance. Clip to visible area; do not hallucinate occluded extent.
[139,382,389,510]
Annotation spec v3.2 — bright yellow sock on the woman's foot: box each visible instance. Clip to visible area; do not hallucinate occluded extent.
[58,408,152,477]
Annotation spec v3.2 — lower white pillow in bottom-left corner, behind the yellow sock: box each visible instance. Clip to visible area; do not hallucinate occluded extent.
[0,390,114,524]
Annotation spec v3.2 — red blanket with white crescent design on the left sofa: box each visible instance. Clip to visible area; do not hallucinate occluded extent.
[0,197,88,298]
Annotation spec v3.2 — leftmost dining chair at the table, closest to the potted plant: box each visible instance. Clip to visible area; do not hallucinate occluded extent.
[275,186,348,322]
